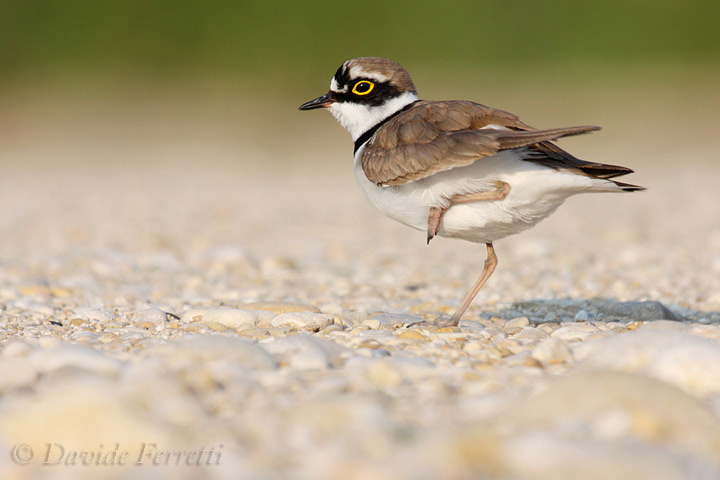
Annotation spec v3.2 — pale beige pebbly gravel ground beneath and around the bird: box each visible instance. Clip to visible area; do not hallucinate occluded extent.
[0,91,720,480]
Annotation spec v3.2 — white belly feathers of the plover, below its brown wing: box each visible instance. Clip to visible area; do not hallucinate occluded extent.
[355,149,620,243]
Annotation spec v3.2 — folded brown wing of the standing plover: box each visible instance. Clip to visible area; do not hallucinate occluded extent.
[361,101,599,185]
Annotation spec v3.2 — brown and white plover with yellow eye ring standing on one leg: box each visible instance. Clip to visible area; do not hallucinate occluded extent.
[299,57,645,327]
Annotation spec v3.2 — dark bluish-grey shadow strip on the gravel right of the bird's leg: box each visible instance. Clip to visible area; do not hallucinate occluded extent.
[480,298,720,325]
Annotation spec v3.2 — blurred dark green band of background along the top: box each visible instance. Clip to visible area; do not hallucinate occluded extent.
[0,0,720,88]
